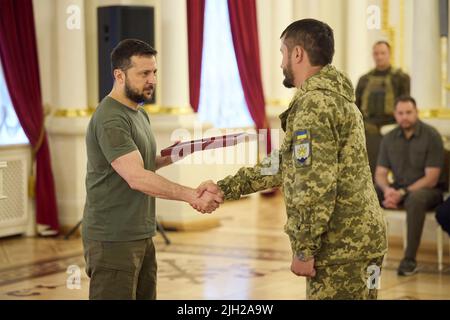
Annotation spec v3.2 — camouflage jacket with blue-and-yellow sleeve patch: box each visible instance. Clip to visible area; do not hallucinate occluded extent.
[218,65,387,266]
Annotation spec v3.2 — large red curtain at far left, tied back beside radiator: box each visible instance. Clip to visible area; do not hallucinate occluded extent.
[0,0,59,230]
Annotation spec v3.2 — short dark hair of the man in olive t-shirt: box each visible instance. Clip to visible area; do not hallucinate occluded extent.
[111,39,157,74]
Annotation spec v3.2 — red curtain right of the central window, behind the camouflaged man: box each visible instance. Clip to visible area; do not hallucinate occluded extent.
[228,0,271,152]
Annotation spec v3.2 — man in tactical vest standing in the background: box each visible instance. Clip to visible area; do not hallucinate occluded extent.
[356,41,410,177]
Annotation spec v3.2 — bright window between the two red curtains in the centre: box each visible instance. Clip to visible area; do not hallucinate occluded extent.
[198,0,254,128]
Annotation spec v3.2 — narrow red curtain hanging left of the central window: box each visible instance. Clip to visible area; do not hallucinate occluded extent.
[187,0,205,112]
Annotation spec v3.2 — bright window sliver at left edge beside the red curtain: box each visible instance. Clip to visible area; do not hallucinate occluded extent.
[0,59,28,146]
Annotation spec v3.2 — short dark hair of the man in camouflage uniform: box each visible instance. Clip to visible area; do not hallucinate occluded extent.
[280,19,334,66]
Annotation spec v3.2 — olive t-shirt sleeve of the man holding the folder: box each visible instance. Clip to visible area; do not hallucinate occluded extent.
[97,119,137,163]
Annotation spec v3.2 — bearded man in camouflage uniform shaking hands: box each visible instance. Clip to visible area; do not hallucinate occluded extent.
[199,19,386,299]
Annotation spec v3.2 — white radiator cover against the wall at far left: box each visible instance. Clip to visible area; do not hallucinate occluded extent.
[0,146,34,237]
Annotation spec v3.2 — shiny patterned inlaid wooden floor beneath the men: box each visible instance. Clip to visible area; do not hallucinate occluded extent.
[0,192,450,299]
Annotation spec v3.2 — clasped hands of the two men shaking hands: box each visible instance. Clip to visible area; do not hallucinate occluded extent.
[189,180,224,213]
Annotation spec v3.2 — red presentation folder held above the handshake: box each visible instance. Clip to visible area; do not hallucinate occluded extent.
[161,132,257,157]
